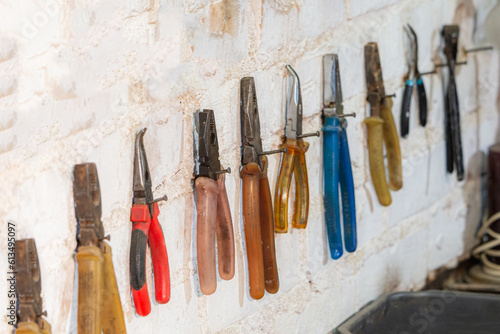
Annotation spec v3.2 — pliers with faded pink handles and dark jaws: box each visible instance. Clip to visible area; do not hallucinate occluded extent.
[194,109,234,295]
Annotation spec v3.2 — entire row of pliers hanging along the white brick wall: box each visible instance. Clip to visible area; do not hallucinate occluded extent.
[12,25,492,334]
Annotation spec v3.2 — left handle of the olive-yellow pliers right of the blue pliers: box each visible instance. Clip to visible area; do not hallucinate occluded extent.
[364,116,392,206]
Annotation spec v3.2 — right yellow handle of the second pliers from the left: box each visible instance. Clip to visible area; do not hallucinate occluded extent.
[101,242,127,334]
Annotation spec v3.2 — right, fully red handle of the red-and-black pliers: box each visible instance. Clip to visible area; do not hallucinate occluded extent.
[148,203,170,304]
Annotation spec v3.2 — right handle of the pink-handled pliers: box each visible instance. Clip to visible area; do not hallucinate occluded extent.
[215,174,235,280]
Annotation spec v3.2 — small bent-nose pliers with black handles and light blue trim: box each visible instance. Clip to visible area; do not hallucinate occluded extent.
[401,24,427,137]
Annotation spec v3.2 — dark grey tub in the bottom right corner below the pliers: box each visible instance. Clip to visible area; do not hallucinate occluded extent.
[333,290,500,334]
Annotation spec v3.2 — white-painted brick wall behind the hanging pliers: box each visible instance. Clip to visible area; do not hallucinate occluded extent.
[0,0,499,333]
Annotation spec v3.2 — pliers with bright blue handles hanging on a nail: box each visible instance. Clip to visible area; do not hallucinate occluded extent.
[322,54,357,259]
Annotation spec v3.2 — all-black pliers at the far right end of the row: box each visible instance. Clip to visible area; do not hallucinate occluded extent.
[441,25,464,181]
